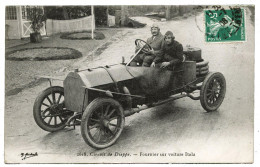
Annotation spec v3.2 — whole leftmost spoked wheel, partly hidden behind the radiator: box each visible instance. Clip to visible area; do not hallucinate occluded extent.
[33,86,73,132]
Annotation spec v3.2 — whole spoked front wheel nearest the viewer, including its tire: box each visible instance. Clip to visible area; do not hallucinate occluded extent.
[81,98,125,149]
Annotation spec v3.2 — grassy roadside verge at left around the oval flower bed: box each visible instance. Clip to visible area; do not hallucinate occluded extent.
[5,28,121,96]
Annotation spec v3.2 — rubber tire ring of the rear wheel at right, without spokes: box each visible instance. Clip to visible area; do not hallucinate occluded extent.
[200,72,226,112]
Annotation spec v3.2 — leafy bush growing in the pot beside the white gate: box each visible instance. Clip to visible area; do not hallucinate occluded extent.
[26,6,46,33]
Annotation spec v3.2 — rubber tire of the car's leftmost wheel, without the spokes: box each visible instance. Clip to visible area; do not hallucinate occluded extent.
[33,86,66,132]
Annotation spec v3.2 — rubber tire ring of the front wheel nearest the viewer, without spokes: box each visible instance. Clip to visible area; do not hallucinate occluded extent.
[80,97,125,149]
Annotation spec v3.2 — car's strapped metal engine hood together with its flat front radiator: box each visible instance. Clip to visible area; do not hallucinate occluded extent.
[63,64,133,112]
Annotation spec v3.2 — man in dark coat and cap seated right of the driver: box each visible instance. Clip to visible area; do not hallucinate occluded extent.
[151,31,183,70]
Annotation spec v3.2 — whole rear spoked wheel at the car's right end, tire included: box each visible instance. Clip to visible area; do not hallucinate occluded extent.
[200,72,226,112]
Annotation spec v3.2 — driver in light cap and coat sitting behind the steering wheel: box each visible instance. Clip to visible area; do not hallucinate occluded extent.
[130,23,164,67]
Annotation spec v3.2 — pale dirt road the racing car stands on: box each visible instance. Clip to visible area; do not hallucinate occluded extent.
[5,11,255,163]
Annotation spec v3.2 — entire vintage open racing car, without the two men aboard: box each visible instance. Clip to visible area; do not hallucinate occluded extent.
[33,39,226,149]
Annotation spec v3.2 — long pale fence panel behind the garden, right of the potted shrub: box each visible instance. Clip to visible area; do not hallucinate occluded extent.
[46,16,95,36]
